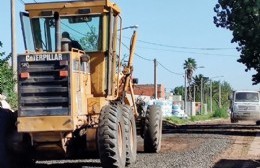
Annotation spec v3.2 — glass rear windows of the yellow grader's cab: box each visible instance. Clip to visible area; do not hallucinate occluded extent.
[31,16,102,52]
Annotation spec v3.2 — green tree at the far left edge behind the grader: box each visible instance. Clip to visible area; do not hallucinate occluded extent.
[0,42,17,108]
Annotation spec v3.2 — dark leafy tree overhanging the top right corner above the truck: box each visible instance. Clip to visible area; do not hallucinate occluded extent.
[214,0,260,85]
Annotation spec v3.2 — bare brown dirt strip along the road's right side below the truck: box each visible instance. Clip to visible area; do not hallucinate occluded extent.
[210,122,260,168]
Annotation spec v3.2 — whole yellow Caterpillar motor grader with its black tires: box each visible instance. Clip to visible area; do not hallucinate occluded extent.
[14,0,162,167]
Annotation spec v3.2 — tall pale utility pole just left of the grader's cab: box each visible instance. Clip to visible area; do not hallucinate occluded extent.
[11,0,17,91]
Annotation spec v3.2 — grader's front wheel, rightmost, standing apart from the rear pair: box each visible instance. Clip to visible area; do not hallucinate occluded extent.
[144,105,162,153]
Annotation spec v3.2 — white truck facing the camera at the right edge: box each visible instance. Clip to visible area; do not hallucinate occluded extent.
[230,90,260,125]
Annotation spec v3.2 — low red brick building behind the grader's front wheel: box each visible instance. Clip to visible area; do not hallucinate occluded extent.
[134,84,165,99]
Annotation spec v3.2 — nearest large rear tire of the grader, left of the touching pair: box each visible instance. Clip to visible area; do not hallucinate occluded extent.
[97,105,126,168]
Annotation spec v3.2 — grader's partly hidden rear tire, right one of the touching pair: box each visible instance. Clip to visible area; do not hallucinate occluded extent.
[121,105,137,166]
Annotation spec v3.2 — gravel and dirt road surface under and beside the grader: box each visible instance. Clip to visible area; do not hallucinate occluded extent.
[22,120,260,168]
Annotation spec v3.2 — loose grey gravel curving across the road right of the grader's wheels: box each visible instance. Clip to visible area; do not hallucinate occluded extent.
[129,134,231,168]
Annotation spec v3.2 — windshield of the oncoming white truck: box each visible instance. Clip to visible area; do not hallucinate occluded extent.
[235,92,259,102]
